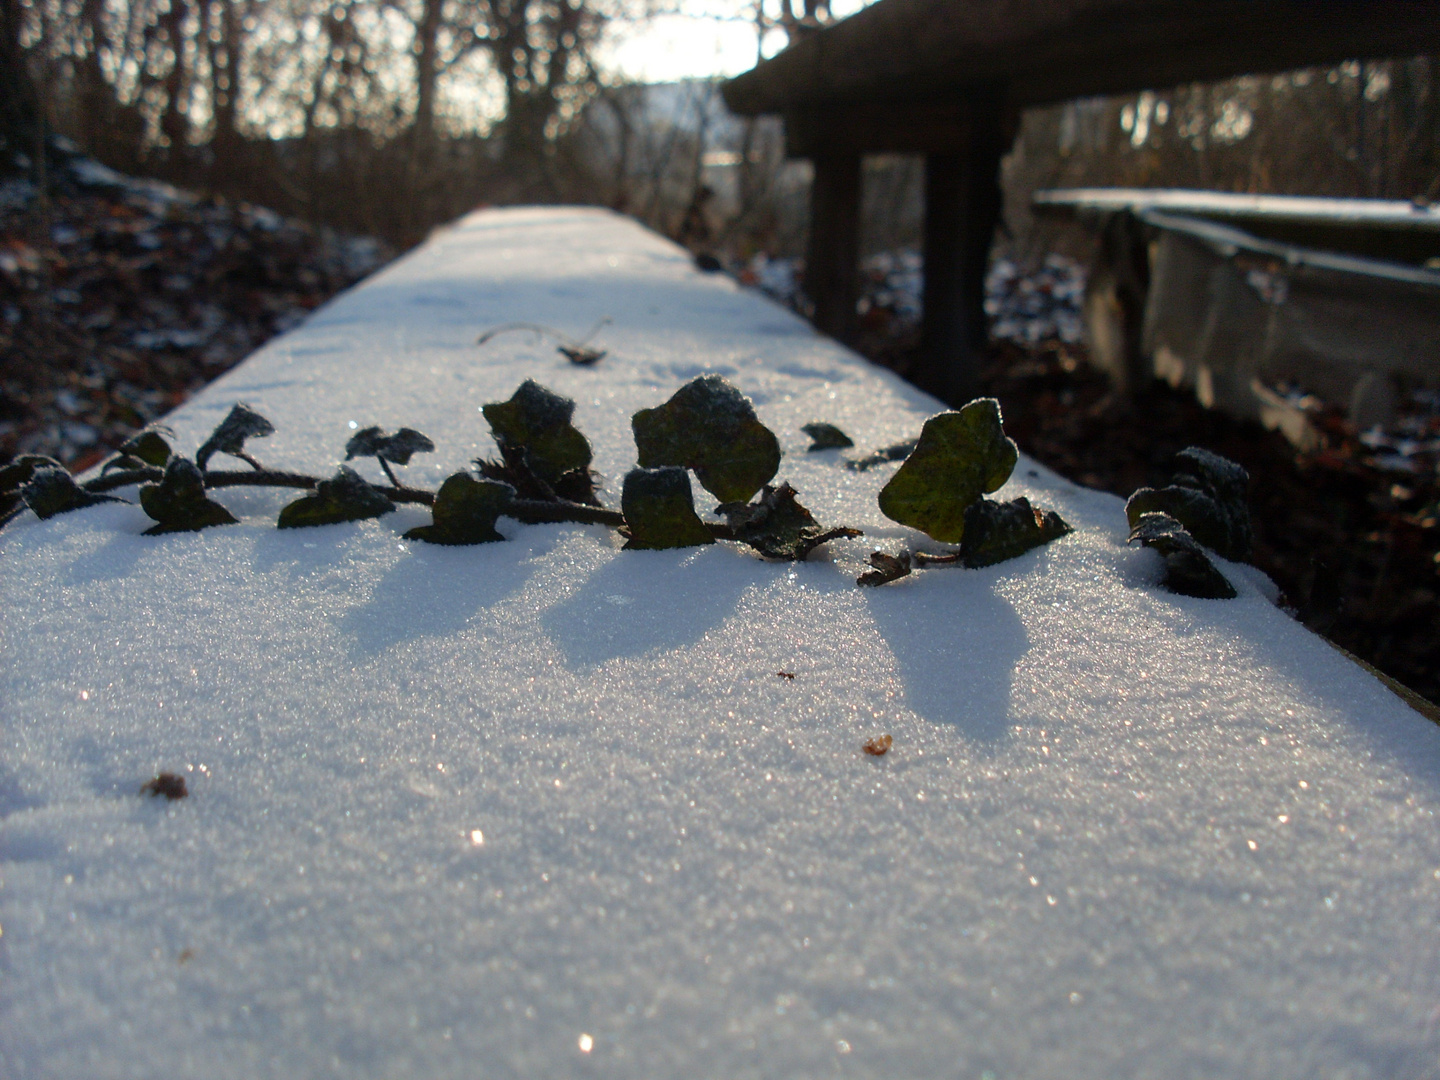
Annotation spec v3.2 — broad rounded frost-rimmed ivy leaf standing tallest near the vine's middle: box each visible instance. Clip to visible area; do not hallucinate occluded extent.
[631,374,780,503]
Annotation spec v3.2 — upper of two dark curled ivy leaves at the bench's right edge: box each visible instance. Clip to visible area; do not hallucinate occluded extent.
[1125,446,1251,562]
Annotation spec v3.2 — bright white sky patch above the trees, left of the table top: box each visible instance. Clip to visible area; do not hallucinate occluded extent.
[603,0,867,82]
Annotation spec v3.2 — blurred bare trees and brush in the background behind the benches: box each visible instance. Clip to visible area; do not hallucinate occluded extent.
[0,0,1440,259]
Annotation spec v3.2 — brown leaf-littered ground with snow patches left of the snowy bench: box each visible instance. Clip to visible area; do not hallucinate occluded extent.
[0,168,386,469]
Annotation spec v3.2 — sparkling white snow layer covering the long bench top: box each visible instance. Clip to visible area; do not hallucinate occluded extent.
[0,209,1440,1080]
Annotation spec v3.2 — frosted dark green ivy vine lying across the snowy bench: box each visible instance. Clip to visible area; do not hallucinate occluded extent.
[0,376,1250,596]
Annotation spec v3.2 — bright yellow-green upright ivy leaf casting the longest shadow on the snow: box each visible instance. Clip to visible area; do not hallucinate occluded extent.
[880,397,1018,544]
